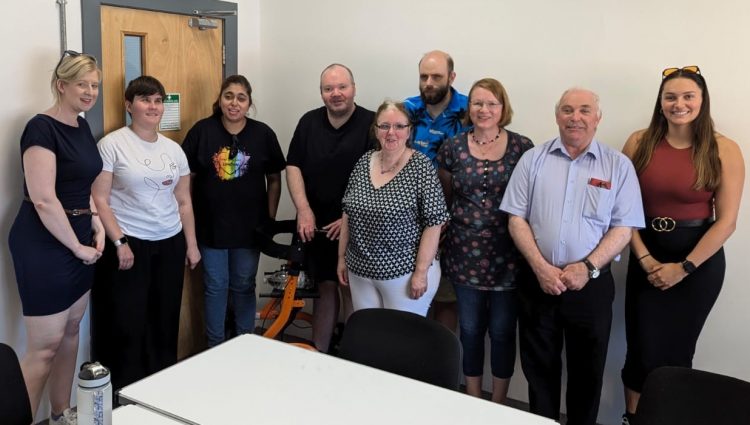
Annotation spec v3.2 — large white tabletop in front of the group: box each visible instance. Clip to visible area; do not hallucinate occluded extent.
[120,335,555,425]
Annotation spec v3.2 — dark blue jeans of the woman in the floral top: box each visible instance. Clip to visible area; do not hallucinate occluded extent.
[454,285,518,379]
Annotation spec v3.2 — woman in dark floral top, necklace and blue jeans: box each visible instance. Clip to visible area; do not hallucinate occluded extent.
[438,78,533,403]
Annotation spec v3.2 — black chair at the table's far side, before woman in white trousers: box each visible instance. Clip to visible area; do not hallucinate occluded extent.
[339,308,461,390]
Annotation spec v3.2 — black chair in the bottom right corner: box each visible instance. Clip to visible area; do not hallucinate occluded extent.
[632,367,750,425]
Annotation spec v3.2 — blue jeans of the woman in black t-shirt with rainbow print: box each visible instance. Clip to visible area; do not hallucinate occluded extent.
[199,245,260,347]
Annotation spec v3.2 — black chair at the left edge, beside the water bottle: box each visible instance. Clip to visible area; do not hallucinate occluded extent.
[0,342,34,425]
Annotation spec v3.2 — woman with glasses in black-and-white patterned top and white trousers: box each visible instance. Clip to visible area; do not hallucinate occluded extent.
[338,101,450,316]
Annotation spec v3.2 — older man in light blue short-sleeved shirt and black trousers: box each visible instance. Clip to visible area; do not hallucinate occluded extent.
[500,88,644,425]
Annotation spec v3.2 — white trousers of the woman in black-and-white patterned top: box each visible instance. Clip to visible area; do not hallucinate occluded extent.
[349,260,440,316]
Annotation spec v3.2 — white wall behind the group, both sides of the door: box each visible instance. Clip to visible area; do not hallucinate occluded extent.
[0,0,750,424]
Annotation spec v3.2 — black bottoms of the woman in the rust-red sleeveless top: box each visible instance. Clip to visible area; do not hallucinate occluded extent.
[622,225,726,392]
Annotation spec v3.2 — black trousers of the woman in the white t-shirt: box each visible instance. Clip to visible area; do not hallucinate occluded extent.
[91,232,187,390]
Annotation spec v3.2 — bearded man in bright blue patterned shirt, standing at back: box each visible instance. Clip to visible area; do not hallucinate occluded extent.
[404,50,468,332]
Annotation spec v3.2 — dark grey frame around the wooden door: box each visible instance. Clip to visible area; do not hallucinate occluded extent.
[81,0,238,140]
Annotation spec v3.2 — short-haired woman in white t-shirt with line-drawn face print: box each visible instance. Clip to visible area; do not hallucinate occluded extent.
[91,76,201,389]
